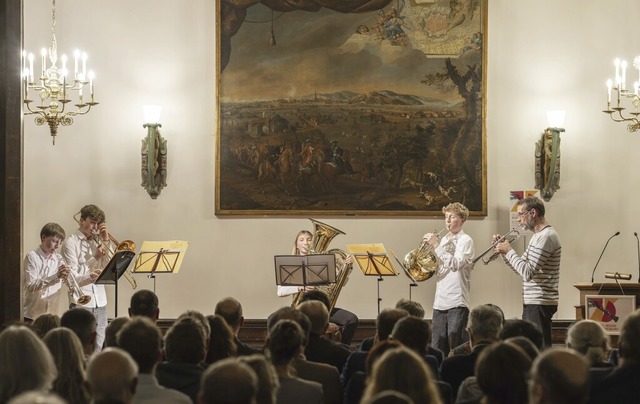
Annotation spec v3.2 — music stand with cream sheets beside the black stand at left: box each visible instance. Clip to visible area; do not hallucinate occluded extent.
[133,240,189,293]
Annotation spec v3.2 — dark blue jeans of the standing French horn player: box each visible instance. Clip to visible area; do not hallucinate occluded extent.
[431,307,469,358]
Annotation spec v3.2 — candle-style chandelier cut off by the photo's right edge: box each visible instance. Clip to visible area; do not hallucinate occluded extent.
[602,56,640,132]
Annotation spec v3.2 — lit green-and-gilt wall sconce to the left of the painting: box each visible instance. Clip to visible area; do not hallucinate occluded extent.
[141,105,167,199]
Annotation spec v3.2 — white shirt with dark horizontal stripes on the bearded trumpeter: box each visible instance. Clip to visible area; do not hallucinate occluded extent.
[505,226,562,305]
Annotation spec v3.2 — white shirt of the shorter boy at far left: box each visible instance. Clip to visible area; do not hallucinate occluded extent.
[23,247,62,319]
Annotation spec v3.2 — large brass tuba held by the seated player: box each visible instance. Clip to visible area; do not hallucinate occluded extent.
[291,219,353,314]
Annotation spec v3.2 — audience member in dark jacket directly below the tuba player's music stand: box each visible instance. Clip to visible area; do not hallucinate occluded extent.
[298,300,351,373]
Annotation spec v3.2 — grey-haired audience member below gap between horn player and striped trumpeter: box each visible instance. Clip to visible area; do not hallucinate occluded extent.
[440,305,504,399]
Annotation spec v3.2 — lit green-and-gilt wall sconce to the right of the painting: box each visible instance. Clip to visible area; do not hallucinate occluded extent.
[535,111,565,202]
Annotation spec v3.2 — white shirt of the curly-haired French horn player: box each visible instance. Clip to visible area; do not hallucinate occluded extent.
[433,230,474,310]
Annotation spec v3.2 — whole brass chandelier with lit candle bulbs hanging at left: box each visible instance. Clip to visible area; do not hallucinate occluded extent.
[22,0,98,145]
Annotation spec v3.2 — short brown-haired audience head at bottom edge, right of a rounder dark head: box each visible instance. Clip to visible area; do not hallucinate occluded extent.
[529,348,589,404]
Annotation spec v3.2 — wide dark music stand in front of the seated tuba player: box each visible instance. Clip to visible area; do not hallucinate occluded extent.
[273,254,336,288]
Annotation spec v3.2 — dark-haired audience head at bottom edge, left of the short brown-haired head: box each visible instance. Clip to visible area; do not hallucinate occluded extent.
[475,342,532,404]
